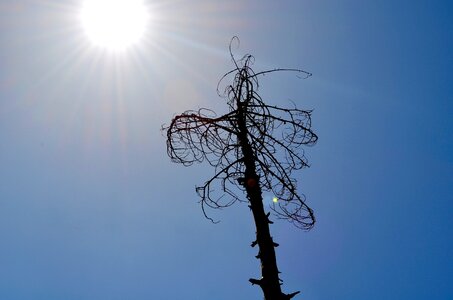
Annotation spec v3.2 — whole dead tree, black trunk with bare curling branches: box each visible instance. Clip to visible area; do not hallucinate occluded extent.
[162,37,317,300]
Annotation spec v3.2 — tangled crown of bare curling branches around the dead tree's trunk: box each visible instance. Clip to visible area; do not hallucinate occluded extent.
[163,41,318,229]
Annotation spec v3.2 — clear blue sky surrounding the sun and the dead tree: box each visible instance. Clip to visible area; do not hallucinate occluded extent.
[0,0,453,300]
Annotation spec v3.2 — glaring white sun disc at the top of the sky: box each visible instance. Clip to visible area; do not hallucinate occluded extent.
[80,0,149,51]
